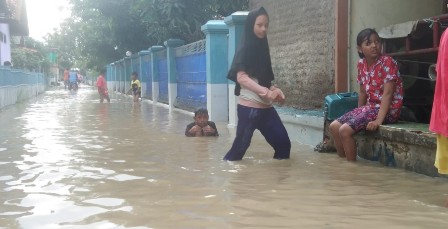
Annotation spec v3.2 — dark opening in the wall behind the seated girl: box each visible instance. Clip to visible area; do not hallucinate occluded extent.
[383,15,448,123]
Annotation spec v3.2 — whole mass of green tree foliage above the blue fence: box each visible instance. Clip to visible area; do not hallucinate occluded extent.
[46,0,248,70]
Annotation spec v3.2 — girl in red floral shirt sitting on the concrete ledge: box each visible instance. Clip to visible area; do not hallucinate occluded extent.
[330,29,403,161]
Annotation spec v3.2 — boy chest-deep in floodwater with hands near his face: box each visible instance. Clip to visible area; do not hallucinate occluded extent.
[185,108,219,137]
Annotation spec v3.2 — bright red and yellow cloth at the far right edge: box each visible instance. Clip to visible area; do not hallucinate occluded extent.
[429,27,448,207]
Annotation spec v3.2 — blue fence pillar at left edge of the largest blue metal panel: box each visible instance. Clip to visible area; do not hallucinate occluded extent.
[164,39,185,110]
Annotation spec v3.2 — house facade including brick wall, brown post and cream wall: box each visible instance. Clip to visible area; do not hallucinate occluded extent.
[250,0,447,113]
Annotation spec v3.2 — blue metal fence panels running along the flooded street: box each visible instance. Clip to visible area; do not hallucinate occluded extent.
[106,40,207,110]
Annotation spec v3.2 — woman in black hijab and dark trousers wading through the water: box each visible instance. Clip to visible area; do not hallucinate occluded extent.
[224,7,291,161]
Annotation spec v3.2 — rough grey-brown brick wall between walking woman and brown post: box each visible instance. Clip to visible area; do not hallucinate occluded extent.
[250,0,335,109]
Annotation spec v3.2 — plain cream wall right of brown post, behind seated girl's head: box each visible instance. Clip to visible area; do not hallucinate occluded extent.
[348,0,443,91]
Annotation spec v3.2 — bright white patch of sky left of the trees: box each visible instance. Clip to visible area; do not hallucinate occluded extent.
[26,0,70,41]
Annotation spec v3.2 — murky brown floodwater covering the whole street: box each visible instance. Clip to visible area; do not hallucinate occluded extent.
[0,87,448,228]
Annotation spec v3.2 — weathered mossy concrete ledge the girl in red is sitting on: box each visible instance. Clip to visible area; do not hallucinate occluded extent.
[355,122,438,176]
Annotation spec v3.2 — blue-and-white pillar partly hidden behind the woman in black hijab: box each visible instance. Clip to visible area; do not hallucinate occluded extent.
[224,12,249,127]
